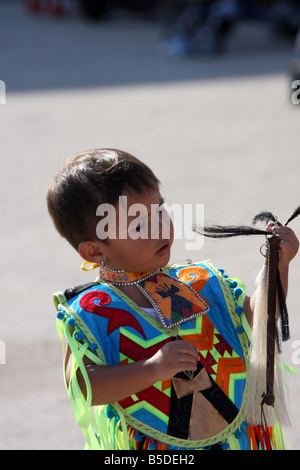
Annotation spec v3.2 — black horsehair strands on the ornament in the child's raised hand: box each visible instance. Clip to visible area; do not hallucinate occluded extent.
[193,206,300,350]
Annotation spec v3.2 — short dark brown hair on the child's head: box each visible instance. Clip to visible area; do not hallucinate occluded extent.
[47,149,159,250]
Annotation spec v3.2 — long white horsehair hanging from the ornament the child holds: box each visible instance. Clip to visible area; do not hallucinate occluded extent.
[246,264,290,426]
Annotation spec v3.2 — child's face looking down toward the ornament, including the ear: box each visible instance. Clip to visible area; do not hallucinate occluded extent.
[102,189,174,272]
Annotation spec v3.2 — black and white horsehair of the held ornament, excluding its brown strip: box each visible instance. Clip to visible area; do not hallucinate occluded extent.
[194,206,300,428]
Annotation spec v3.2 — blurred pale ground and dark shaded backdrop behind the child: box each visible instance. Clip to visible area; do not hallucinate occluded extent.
[0,0,300,450]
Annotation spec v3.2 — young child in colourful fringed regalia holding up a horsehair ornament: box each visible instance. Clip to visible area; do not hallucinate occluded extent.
[47,149,298,449]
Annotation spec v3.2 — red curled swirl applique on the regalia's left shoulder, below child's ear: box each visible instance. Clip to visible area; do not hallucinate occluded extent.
[79,290,146,338]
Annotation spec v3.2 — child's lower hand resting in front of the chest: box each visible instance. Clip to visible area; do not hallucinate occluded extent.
[147,340,200,381]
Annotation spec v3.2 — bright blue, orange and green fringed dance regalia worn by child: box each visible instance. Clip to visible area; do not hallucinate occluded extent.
[54,262,284,450]
